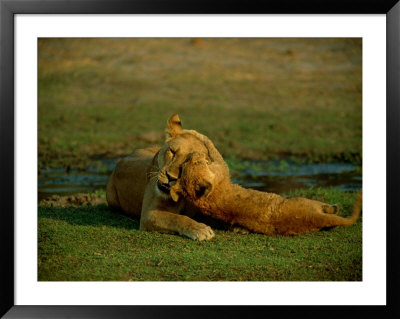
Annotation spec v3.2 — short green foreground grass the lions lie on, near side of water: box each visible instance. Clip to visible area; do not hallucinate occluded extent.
[38,188,362,281]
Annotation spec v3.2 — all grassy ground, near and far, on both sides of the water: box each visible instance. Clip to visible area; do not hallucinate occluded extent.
[38,39,362,280]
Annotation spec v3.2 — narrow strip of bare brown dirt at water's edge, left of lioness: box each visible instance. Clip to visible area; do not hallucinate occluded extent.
[39,193,107,207]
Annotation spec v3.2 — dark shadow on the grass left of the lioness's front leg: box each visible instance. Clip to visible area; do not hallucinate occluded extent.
[38,204,139,229]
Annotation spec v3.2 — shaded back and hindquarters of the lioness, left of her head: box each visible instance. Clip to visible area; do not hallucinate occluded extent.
[106,147,160,217]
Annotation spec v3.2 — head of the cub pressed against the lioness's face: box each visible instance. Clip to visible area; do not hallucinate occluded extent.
[171,152,217,201]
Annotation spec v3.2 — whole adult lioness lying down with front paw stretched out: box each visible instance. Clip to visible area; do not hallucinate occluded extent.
[106,114,225,240]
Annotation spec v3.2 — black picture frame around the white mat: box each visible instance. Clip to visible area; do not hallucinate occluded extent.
[0,0,400,318]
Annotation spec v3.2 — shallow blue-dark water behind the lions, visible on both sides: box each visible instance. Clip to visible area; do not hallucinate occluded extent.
[38,160,362,200]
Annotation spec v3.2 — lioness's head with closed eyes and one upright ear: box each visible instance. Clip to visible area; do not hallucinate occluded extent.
[156,114,215,201]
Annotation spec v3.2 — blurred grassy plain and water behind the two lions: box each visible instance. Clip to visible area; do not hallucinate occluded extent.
[38,38,362,198]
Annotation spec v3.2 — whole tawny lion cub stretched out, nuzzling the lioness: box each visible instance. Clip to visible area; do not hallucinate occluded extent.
[174,153,362,235]
